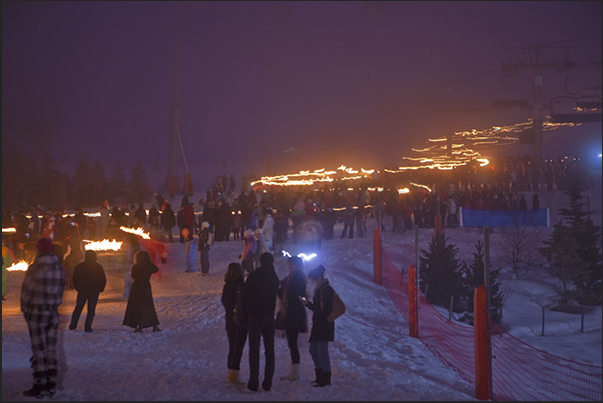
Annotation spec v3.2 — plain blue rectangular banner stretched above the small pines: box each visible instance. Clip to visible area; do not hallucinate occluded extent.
[459,207,550,227]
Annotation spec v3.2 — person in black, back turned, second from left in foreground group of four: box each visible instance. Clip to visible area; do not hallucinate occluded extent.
[241,252,279,392]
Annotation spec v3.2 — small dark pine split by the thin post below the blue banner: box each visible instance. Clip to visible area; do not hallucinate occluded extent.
[461,241,504,325]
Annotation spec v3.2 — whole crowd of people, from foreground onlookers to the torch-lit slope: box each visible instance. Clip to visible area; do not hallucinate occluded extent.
[2,157,596,397]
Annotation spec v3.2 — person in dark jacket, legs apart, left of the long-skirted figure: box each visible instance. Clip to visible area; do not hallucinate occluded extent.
[69,250,107,333]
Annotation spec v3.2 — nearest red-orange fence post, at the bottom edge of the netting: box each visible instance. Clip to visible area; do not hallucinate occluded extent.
[473,285,492,400]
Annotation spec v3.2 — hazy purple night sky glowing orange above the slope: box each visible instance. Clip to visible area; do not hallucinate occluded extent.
[2,1,603,177]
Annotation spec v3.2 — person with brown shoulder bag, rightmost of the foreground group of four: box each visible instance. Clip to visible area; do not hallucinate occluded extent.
[300,265,335,386]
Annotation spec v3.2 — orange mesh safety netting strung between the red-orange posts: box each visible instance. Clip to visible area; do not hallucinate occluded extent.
[381,248,603,401]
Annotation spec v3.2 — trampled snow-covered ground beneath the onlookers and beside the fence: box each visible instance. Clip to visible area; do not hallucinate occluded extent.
[2,176,602,401]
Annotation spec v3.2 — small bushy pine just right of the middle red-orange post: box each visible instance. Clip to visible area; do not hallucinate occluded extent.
[419,232,463,310]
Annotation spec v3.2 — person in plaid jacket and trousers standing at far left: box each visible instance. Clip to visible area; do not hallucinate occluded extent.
[21,237,65,398]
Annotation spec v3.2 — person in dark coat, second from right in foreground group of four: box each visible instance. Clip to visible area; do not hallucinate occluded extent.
[277,256,308,381]
